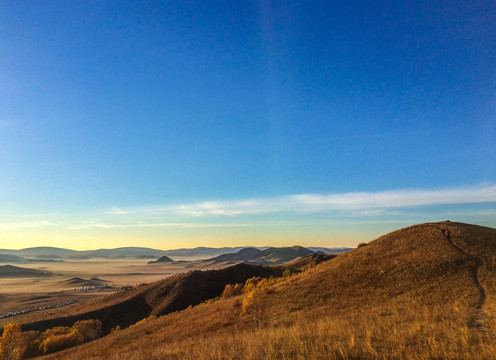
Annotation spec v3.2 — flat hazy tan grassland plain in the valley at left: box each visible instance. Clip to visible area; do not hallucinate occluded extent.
[0,259,226,326]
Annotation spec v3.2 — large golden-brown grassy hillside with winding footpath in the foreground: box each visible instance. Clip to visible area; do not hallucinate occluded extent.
[9,222,496,359]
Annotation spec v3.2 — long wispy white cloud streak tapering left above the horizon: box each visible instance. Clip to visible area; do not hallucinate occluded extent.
[112,184,496,217]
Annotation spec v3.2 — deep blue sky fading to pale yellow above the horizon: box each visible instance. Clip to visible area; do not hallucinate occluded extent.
[0,1,496,249]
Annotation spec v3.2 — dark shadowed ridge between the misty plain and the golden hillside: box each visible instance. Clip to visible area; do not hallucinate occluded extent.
[22,264,283,333]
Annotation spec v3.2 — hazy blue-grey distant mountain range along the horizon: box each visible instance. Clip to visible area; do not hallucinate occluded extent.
[0,246,351,263]
